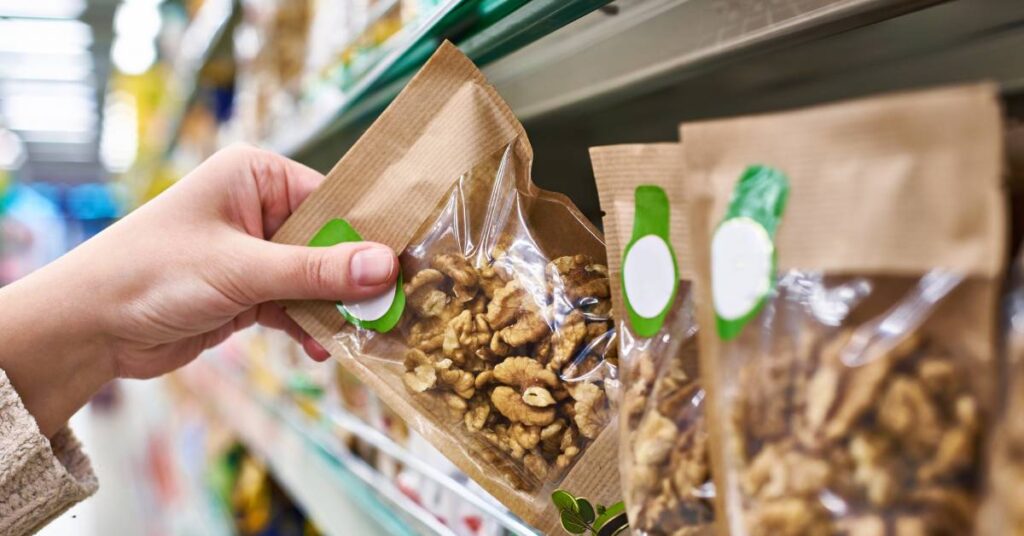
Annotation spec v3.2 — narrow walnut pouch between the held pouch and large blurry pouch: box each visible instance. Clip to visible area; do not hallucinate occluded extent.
[590,143,714,535]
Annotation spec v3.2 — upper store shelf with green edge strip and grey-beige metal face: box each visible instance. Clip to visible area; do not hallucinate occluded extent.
[268,0,921,164]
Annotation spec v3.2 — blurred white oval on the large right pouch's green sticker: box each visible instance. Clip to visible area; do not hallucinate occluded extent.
[711,217,774,320]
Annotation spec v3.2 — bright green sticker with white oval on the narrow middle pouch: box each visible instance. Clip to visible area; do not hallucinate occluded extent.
[622,185,679,337]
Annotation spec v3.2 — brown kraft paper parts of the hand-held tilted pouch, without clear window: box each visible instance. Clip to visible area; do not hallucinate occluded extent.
[273,42,620,534]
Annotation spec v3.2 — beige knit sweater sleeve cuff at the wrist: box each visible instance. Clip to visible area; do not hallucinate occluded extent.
[0,370,97,536]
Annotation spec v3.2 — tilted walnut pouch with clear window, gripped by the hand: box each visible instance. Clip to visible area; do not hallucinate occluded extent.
[273,43,620,534]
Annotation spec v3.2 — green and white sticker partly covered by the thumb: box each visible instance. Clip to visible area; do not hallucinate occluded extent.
[309,219,406,333]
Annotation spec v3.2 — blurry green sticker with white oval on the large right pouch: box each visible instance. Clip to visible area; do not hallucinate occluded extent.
[711,166,790,340]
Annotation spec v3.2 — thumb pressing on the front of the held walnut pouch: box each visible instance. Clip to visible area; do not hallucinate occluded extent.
[244,239,398,303]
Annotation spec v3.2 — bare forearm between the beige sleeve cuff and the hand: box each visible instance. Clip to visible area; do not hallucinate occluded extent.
[0,261,116,437]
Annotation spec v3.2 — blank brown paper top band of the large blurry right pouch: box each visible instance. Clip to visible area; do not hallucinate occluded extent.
[680,84,1006,277]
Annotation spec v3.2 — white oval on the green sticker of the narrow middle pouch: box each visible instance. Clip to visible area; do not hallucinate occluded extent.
[623,235,676,319]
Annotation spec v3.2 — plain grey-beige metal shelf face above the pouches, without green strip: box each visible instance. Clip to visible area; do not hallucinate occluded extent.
[485,0,938,120]
